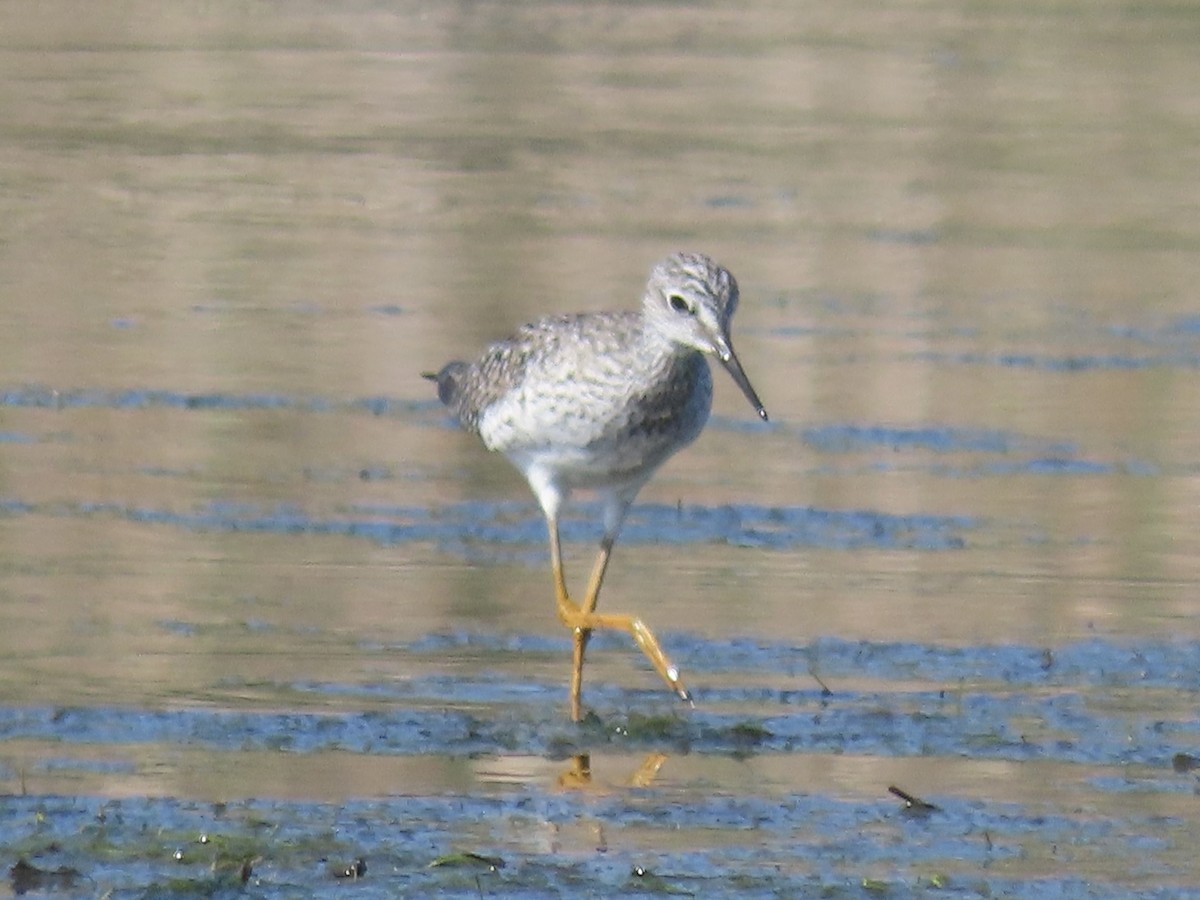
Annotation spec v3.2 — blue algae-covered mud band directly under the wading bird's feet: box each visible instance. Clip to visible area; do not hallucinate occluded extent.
[0,635,1200,769]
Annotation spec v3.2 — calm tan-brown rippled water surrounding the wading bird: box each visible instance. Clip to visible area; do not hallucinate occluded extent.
[0,0,1200,897]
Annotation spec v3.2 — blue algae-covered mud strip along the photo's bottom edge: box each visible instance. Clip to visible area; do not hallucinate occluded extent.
[0,786,1195,900]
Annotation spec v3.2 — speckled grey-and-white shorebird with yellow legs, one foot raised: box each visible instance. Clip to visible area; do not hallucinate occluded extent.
[425,253,767,721]
